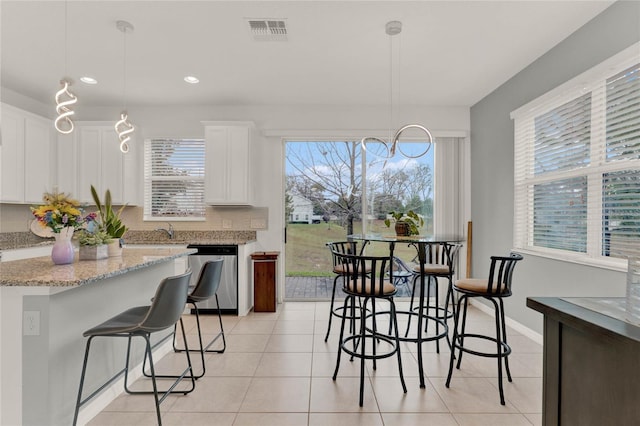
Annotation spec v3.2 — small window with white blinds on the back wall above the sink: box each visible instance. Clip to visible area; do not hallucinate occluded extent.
[144,139,205,220]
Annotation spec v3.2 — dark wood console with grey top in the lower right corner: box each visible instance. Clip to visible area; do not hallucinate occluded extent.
[527,297,640,426]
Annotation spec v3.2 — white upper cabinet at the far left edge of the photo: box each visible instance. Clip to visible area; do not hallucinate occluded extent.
[0,104,55,204]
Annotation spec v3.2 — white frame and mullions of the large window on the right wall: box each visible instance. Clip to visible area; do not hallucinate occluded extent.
[511,43,640,271]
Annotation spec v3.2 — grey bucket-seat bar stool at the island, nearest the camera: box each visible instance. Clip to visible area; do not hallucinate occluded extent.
[73,271,195,425]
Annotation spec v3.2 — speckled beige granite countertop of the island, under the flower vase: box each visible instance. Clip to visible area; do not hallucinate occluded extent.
[0,247,196,287]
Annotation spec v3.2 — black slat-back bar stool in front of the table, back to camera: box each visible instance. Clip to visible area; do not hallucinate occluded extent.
[333,251,407,407]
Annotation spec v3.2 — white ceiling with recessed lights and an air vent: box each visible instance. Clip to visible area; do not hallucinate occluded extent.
[0,0,613,110]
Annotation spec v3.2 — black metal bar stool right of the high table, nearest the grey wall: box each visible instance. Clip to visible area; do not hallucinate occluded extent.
[446,253,522,405]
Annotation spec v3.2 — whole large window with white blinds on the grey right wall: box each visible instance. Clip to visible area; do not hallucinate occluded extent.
[511,45,640,266]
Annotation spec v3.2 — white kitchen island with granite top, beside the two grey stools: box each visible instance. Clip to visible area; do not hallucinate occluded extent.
[0,247,194,425]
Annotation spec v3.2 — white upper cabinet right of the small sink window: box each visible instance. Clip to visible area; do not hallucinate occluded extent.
[203,121,255,205]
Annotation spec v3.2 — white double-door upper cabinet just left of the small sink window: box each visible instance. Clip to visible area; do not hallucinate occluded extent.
[57,122,138,205]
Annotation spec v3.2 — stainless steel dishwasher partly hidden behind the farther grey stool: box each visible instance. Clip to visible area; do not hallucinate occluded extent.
[187,244,238,315]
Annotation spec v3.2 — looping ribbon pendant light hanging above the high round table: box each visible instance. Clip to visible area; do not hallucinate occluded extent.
[360,21,433,165]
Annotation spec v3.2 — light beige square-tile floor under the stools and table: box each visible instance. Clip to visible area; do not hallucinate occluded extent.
[89,301,542,426]
